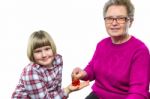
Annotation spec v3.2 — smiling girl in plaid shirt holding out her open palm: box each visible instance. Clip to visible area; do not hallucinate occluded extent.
[12,30,89,99]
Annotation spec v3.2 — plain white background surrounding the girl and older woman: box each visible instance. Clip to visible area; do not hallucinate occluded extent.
[0,0,150,99]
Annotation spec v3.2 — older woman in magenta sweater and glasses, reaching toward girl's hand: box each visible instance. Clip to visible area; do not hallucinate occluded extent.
[72,0,150,99]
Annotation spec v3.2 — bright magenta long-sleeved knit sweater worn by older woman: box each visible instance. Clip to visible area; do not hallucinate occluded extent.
[84,36,150,99]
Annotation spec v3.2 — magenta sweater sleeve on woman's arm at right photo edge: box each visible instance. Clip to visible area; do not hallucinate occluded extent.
[126,48,150,99]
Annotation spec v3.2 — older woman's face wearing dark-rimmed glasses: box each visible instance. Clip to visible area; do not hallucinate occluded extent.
[104,5,131,37]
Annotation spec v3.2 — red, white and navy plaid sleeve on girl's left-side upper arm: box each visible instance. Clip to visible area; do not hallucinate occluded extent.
[22,70,49,99]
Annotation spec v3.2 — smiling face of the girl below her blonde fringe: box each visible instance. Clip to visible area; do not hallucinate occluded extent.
[33,46,54,66]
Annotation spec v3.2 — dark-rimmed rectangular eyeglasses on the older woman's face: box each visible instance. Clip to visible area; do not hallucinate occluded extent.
[104,17,129,24]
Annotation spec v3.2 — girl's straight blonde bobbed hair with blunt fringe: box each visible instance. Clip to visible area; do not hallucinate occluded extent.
[27,30,57,62]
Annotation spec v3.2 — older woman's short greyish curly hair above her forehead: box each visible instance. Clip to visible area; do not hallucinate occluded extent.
[103,0,135,19]
